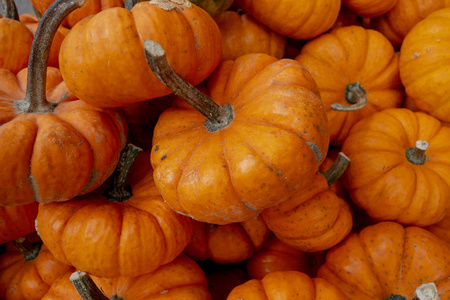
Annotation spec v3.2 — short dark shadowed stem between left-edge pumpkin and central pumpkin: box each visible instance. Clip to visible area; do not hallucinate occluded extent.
[104,144,143,202]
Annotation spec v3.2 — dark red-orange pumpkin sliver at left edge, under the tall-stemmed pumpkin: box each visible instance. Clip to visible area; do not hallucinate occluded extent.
[0,202,38,244]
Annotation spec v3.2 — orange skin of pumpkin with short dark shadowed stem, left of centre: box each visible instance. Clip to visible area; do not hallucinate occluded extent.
[36,172,192,277]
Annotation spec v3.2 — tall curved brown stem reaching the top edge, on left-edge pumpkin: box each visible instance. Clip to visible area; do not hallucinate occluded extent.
[15,0,86,113]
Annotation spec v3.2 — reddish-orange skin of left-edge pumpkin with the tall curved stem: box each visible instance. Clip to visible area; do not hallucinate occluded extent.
[0,68,127,205]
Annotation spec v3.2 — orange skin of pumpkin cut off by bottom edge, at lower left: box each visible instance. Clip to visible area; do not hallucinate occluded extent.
[42,254,211,300]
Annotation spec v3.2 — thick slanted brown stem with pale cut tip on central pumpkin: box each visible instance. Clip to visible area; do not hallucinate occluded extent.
[144,40,234,132]
